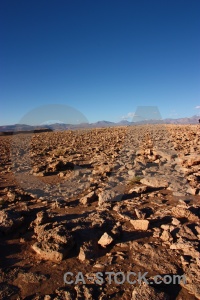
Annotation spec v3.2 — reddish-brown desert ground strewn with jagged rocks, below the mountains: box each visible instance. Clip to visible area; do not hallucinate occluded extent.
[0,124,200,300]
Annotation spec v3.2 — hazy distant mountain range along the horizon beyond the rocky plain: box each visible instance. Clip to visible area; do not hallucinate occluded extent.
[0,115,200,134]
